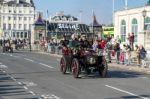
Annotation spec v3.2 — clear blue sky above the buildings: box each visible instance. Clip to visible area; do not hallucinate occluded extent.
[33,0,147,24]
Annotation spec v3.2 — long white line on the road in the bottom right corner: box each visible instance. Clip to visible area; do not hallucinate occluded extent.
[105,85,149,99]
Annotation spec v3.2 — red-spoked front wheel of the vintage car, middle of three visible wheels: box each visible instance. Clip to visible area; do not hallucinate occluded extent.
[72,59,80,78]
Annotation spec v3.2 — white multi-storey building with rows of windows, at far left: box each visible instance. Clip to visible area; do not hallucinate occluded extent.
[0,0,35,39]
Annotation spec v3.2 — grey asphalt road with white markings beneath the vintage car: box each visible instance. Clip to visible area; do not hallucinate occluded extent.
[0,51,150,99]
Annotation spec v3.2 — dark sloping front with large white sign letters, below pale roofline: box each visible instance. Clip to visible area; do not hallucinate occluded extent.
[48,23,91,40]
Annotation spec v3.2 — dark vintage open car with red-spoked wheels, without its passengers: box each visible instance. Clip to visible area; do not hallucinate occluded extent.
[60,47,108,78]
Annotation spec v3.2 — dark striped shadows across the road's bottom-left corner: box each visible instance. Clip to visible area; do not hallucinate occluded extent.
[0,73,38,99]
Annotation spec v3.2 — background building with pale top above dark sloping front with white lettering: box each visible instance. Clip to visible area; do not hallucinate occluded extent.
[47,12,90,39]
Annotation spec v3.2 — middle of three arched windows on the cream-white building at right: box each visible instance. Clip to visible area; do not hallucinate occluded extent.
[132,18,138,42]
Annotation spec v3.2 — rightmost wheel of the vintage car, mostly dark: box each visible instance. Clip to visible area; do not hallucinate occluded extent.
[99,57,108,77]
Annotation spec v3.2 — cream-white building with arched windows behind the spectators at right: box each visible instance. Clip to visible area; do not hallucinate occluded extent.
[114,5,150,44]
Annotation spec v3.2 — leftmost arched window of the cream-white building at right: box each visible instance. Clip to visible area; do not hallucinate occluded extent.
[120,20,126,42]
